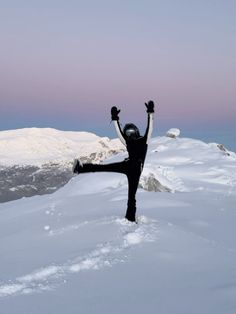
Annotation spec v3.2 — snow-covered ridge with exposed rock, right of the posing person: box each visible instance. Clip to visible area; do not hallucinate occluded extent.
[140,136,236,192]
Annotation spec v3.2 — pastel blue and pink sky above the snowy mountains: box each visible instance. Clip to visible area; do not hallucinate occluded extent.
[0,0,236,144]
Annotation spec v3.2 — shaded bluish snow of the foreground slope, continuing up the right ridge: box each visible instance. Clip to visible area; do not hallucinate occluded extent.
[0,137,236,314]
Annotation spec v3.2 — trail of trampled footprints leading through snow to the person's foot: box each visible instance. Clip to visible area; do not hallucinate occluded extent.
[0,216,158,297]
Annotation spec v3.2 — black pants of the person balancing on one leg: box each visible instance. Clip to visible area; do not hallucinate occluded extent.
[79,159,143,221]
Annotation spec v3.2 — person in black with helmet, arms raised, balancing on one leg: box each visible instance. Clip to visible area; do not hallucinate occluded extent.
[73,100,154,222]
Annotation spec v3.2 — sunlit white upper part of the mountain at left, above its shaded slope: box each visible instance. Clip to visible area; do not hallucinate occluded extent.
[0,128,124,166]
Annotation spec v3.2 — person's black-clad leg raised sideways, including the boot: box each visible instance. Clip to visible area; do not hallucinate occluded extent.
[73,160,127,174]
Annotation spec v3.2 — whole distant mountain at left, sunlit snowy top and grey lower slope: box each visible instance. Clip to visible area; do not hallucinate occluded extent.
[0,128,124,202]
